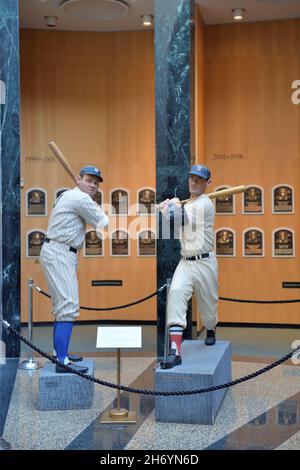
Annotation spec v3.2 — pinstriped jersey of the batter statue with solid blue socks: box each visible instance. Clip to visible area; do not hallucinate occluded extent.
[47,187,108,249]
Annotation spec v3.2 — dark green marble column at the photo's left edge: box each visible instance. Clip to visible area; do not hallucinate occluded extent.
[0,0,20,357]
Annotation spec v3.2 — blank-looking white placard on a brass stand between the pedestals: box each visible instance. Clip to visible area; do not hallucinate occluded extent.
[96,326,142,348]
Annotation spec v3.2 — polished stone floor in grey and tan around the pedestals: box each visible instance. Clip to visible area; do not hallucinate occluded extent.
[0,325,300,450]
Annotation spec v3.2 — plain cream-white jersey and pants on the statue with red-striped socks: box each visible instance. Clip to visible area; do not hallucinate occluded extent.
[167,194,218,330]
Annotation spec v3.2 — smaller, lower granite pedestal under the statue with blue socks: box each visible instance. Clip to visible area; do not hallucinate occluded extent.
[39,359,95,411]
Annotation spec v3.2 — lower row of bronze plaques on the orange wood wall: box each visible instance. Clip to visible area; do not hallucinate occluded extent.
[26,227,295,258]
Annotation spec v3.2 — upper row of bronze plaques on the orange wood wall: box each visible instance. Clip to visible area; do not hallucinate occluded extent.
[26,185,294,216]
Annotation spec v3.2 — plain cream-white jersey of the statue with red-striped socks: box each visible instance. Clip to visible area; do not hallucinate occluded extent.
[179,194,215,256]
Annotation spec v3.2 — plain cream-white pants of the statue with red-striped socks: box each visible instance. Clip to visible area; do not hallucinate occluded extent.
[167,253,218,330]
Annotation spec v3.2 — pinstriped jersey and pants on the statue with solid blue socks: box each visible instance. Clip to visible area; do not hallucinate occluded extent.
[40,188,108,321]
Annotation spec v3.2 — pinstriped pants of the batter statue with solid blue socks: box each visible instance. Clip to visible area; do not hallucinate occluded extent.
[40,240,79,321]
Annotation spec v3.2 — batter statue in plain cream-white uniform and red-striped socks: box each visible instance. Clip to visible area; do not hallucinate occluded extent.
[159,165,218,369]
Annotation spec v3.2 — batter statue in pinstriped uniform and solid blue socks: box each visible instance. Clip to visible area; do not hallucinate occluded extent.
[40,166,108,373]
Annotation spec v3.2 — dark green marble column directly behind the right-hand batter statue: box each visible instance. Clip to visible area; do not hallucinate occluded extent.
[155,0,194,356]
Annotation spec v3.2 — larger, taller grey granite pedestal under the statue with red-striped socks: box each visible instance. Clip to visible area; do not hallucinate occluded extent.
[154,340,231,424]
